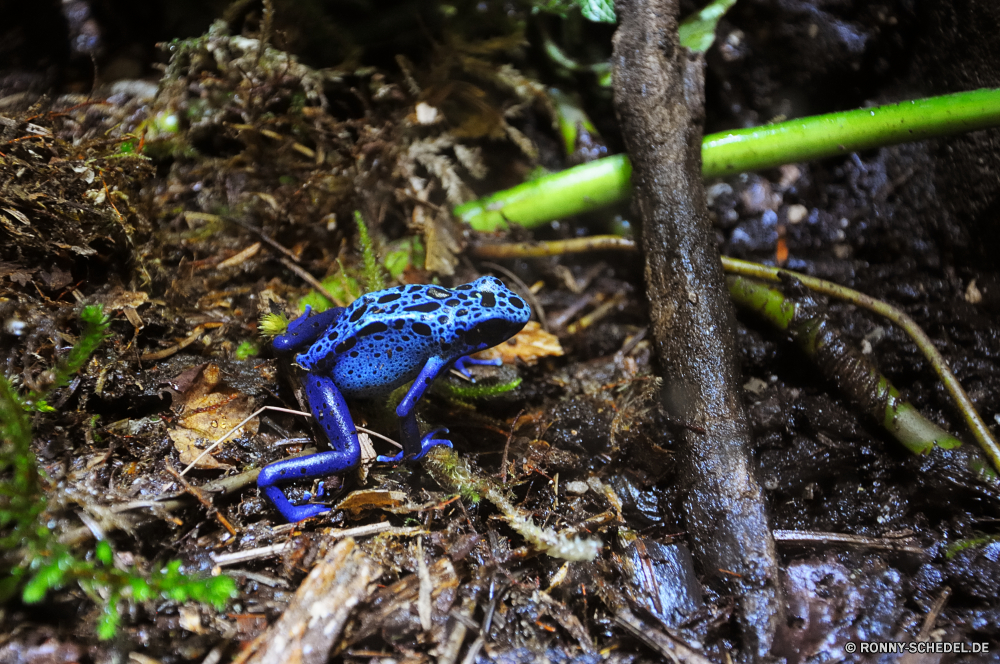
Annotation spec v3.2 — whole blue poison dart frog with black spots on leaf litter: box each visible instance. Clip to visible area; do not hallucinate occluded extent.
[257,277,531,521]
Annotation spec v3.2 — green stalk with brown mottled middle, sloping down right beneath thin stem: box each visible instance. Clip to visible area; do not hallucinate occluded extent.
[726,275,1000,487]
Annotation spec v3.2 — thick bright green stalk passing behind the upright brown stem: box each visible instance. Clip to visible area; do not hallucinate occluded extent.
[454,89,1000,232]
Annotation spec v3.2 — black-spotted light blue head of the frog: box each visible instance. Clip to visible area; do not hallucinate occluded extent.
[454,277,531,353]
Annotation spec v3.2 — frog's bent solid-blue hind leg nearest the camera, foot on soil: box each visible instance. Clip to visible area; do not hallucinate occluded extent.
[257,373,361,521]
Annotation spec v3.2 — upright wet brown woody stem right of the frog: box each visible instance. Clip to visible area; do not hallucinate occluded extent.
[613,0,782,661]
